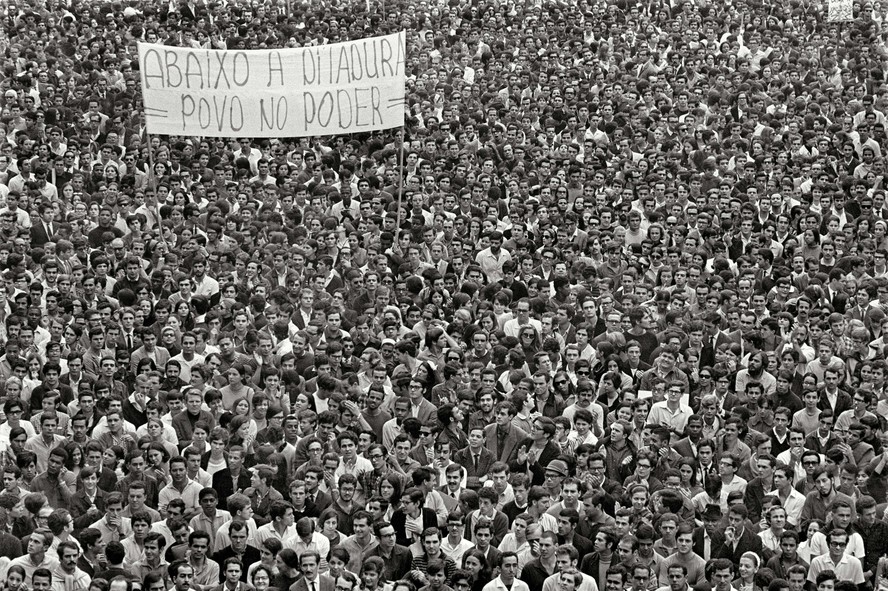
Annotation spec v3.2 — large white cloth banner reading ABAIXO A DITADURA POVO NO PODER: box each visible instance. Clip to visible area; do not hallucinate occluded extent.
[139,32,406,137]
